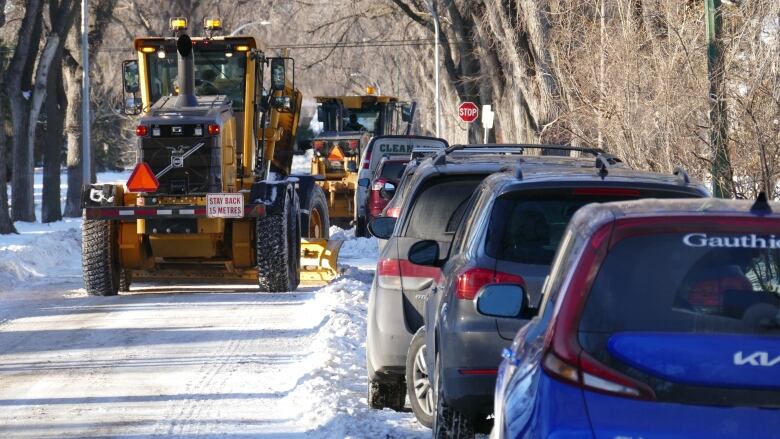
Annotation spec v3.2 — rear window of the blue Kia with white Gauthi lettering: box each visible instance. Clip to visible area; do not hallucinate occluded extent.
[580,233,780,336]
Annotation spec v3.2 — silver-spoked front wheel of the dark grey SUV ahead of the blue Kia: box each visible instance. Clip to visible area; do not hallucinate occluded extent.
[406,328,436,428]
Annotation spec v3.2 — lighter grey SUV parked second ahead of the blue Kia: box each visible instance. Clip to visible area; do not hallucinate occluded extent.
[366,148,532,418]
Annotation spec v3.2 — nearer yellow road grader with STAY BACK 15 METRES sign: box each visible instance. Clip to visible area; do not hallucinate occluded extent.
[82,18,340,296]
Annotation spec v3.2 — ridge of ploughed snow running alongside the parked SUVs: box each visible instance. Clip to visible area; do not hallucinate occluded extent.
[282,276,430,438]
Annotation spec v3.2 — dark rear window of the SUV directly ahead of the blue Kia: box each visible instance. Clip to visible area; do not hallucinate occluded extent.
[486,188,652,265]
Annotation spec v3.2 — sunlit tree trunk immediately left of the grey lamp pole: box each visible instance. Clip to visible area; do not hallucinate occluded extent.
[63,51,83,218]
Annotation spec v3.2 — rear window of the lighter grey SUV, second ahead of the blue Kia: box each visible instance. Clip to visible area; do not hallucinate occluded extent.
[405,176,484,241]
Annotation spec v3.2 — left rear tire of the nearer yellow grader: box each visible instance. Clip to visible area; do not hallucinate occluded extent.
[81,219,120,296]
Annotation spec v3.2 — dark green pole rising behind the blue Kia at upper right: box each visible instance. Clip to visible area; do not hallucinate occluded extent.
[704,0,731,198]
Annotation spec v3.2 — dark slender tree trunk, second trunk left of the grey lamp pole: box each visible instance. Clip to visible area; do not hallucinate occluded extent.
[41,52,67,223]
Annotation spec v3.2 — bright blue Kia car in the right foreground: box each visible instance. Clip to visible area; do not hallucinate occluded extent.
[484,197,780,439]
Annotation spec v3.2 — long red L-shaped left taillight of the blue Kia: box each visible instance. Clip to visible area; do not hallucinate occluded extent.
[542,224,655,400]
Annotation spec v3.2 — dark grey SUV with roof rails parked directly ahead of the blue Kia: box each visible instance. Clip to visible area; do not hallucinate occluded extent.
[407,150,709,438]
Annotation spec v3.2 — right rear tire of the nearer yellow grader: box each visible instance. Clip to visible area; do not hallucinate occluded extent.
[255,194,300,293]
